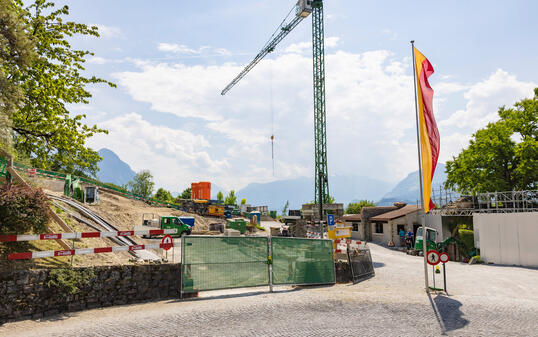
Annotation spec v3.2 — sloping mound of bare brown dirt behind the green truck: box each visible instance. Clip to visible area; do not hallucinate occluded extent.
[87,190,216,232]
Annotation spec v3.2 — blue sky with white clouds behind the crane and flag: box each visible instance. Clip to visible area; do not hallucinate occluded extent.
[58,0,538,190]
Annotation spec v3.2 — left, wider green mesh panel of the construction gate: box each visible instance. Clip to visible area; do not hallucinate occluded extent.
[182,235,269,293]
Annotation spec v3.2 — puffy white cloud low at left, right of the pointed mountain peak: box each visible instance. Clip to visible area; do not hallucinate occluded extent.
[90,113,229,190]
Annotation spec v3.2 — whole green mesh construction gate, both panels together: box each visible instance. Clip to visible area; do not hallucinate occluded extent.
[181,235,336,293]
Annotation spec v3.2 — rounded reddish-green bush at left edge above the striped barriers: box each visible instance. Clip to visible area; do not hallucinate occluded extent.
[0,185,50,234]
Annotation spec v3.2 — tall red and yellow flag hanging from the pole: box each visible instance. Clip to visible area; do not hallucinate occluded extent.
[413,47,439,213]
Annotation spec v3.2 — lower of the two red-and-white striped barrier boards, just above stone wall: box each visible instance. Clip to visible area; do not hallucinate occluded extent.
[8,243,174,260]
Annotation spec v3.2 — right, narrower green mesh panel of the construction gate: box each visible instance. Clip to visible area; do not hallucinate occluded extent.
[271,237,335,284]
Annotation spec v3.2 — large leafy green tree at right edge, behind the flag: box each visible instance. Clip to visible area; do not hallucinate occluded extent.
[445,88,538,194]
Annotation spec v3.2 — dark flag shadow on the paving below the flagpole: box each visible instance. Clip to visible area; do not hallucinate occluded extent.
[428,293,469,335]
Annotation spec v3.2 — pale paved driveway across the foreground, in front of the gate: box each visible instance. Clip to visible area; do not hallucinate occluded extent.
[0,245,538,336]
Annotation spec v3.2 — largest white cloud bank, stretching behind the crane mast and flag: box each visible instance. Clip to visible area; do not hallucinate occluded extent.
[109,42,535,189]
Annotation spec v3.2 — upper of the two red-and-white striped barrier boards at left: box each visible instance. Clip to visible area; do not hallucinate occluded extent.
[0,228,177,242]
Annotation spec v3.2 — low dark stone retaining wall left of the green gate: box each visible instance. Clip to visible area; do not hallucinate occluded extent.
[0,264,180,324]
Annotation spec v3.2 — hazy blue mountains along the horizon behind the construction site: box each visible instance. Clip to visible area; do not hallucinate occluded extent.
[97,148,446,210]
